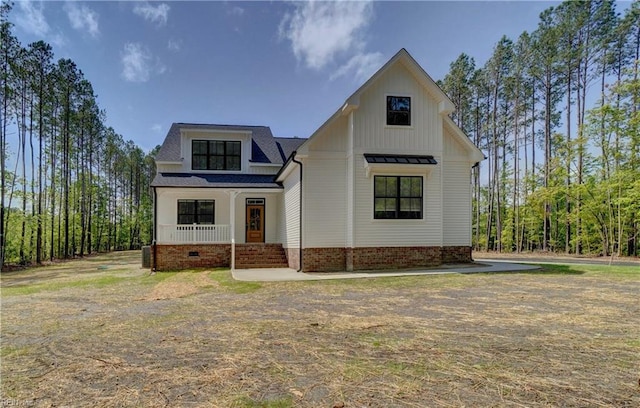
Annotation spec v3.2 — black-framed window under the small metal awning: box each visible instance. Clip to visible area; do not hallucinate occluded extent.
[373,175,424,220]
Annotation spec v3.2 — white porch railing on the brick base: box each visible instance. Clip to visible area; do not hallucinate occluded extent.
[158,224,231,244]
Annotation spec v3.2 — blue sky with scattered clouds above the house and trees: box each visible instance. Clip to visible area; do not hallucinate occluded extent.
[9,1,556,151]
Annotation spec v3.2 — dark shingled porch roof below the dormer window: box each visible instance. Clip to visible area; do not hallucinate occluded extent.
[151,173,281,188]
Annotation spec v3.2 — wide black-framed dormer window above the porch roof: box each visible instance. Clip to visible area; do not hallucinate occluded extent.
[191,140,241,170]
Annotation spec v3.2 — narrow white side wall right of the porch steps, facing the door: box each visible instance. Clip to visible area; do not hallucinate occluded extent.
[279,169,300,248]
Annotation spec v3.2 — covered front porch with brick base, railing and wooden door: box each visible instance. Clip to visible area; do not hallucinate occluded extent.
[153,178,282,270]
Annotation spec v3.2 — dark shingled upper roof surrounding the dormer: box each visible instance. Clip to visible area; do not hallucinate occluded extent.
[156,123,296,164]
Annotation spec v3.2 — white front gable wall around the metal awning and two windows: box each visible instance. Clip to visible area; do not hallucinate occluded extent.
[352,60,443,247]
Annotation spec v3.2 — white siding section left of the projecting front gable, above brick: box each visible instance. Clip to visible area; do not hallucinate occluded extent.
[303,158,347,248]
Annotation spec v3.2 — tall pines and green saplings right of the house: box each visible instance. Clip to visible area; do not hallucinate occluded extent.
[440,0,640,256]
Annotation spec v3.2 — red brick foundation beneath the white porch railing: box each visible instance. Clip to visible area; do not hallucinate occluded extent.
[151,244,231,271]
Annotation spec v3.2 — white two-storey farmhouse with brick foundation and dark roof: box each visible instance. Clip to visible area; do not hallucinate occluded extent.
[152,49,484,271]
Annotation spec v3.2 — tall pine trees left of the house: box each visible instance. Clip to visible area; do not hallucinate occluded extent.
[0,2,155,265]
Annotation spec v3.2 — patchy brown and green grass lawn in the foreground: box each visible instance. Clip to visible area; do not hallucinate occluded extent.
[0,252,640,407]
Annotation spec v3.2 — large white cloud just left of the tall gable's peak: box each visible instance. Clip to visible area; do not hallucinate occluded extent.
[280,1,373,70]
